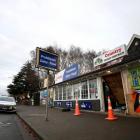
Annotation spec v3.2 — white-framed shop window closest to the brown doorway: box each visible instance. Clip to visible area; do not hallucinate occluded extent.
[89,79,98,99]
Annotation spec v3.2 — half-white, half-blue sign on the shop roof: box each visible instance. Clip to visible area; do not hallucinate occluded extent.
[55,64,79,84]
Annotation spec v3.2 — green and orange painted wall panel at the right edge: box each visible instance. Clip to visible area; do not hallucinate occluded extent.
[126,64,140,115]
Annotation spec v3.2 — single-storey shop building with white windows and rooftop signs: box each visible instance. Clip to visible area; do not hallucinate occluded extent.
[50,35,140,114]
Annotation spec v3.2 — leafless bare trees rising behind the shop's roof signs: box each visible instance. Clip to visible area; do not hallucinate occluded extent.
[31,45,96,79]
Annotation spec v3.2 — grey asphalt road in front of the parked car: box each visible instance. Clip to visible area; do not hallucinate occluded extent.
[0,112,34,140]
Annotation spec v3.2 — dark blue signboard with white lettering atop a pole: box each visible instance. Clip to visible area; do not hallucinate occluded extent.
[37,48,58,70]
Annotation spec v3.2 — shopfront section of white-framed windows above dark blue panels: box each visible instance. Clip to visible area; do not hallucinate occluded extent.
[54,78,102,111]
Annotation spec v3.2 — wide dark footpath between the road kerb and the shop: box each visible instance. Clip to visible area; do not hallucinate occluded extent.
[17,106,140,140]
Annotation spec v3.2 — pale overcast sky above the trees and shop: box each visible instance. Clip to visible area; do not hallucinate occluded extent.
[0,0,140,93]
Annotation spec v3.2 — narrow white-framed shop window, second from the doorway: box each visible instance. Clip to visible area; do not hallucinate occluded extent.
[81,81,88,99]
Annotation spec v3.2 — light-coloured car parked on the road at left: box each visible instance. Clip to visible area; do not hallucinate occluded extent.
[0,96,16,112]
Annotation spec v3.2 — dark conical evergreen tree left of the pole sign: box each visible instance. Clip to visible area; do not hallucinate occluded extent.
[7,62,39,97]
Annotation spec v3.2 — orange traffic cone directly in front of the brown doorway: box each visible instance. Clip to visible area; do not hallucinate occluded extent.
[105,96,117,121]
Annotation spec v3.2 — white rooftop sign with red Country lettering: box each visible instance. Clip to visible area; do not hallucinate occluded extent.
[94,45,127,67]
